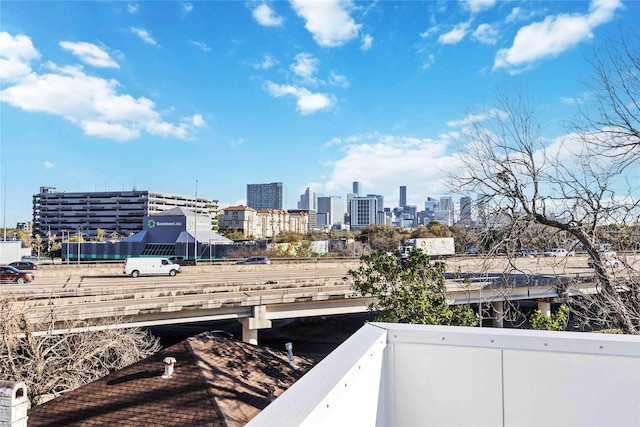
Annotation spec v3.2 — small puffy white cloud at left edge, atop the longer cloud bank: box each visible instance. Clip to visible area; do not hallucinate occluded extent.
[0,32,40,82]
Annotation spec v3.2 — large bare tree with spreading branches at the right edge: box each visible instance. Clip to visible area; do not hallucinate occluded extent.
[450,84,640,334]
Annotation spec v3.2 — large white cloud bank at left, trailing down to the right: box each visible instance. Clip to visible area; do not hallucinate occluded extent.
[0,33,204,141]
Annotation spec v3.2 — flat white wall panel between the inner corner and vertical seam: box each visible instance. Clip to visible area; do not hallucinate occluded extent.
[385,343,502,426]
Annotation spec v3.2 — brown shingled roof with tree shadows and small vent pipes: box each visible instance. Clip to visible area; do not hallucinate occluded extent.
[28,332,312,427]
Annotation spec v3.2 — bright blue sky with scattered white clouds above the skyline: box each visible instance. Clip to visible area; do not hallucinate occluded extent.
[0,0,640,227]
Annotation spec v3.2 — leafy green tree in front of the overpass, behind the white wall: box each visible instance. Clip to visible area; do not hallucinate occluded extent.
[348,249,480,326]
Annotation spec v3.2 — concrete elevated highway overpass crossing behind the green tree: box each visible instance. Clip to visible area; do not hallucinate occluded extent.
[2,259,608,343]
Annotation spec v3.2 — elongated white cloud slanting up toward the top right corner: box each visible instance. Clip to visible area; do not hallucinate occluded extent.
[493,0,622,72]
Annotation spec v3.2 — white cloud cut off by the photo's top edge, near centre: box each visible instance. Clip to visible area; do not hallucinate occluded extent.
[291,0,362,47]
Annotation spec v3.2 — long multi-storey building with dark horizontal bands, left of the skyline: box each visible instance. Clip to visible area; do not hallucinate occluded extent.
[33,187,218,238]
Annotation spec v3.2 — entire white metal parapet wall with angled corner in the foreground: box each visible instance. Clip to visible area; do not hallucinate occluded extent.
[250,323,640,427]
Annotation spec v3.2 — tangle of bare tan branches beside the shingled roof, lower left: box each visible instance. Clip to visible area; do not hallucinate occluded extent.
[0,297,160,405]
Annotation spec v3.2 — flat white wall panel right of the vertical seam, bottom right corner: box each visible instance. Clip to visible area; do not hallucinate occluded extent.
[504,350,640,426]
